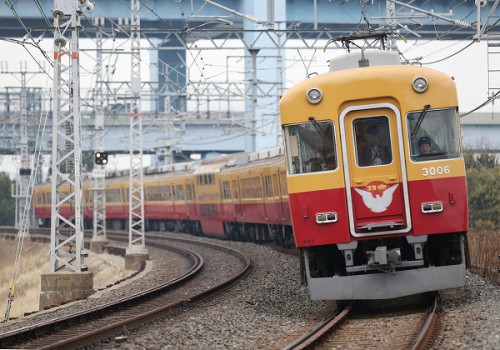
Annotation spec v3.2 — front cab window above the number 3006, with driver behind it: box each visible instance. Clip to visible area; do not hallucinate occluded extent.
[407,108,460,162]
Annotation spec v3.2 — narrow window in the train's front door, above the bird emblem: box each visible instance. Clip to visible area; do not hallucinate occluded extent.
[353,116,392,167]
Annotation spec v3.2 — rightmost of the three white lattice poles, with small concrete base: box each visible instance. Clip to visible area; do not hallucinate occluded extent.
[125,0,149,270]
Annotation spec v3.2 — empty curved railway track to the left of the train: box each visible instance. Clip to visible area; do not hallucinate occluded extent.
[0,230,251,349]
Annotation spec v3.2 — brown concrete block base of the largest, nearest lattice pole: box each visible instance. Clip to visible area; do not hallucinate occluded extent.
[38,272,94,311]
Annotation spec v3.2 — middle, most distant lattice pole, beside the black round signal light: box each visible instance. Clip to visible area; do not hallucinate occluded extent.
[90,18,108,253]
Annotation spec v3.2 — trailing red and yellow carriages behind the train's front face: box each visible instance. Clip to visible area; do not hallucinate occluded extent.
[34,148,294,247]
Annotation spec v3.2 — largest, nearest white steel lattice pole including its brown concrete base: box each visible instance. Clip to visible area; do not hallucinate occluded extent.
[40,0,93,310]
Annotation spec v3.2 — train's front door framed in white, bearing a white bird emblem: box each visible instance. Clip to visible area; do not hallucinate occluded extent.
[340,104,411,237]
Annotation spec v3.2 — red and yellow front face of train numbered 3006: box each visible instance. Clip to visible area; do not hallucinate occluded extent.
[280,61,468,300]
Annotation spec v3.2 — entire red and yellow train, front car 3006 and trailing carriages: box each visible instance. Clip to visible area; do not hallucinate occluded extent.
[34,43,468,300]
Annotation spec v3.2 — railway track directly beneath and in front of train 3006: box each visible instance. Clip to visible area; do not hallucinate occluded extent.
[283,294,439,350]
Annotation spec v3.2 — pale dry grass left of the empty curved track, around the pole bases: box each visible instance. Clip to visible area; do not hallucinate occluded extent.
[0,240,134,321]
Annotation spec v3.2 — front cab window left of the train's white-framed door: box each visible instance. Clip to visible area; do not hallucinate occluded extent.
[284,117,338,174]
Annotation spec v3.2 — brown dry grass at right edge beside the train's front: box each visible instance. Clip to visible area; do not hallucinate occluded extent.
[468,231,500,283]
